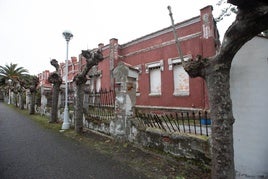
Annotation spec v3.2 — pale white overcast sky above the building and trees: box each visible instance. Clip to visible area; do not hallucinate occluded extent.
[0,0,233,75]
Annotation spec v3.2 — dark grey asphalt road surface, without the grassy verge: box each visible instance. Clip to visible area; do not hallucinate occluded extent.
[0,102,144,179]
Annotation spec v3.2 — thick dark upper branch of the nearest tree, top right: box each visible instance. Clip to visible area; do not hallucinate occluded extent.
[217,0,268,63]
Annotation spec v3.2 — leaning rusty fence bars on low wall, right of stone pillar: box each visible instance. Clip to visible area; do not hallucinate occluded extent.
[135,108,211,136]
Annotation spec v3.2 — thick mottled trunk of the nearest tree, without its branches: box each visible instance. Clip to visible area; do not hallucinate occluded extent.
[206,68,235,179]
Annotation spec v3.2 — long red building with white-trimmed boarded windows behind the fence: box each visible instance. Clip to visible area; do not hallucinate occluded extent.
[38,6,219,109]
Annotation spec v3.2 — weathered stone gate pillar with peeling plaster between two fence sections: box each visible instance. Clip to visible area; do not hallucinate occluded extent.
[110,62,138,140]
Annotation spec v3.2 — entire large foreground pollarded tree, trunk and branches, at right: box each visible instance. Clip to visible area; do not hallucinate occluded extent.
[178,0,268,179]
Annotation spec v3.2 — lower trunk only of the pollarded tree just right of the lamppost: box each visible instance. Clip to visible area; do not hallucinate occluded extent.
[75,83,85,133]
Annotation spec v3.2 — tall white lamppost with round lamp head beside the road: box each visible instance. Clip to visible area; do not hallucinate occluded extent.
[61,31,73,130]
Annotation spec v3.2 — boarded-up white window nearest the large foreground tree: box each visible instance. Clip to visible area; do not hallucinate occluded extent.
[168,55,191,96]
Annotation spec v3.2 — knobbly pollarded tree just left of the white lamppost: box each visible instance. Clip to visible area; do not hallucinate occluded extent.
[48,59,62,123]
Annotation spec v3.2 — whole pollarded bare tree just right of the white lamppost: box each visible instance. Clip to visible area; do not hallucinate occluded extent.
[74,49,103,133]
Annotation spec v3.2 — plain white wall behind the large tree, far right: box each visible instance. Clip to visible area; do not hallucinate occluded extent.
[230,37,268,178]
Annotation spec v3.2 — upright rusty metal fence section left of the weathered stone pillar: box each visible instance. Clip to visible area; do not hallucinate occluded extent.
[86,89,115,122]
